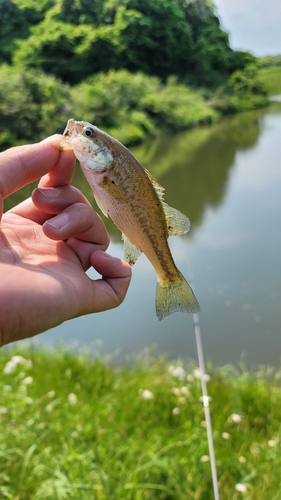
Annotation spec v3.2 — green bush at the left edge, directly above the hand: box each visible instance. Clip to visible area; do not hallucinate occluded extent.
[0,65,72,147]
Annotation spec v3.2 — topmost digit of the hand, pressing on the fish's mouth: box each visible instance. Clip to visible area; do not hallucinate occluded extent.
[0,135,61,199]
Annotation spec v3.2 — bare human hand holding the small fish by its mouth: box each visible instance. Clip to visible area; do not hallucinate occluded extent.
[0,135,131,345]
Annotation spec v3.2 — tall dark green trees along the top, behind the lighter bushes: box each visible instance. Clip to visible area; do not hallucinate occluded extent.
[7,0,249,87]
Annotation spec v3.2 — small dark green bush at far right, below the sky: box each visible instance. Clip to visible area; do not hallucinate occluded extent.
[213,64,268,113]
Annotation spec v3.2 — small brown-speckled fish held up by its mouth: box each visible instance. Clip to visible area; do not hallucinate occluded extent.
[61,118,200,320]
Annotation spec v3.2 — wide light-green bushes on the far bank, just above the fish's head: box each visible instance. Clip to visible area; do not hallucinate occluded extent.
[72,70,216,144]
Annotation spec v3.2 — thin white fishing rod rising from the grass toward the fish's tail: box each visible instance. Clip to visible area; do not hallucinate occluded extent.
[188,261,220,500]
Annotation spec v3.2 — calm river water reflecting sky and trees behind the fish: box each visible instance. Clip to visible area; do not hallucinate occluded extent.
[5,100,281,367]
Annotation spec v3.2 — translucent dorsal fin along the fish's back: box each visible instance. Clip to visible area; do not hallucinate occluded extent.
[145,169,190,236]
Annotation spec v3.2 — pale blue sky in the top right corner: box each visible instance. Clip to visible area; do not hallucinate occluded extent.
[213,0,281,57]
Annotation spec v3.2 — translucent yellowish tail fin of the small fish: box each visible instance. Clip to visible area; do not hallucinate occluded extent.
[156,272,200,320]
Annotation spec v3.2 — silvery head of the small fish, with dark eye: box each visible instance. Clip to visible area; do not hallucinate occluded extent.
[61,118,113,171]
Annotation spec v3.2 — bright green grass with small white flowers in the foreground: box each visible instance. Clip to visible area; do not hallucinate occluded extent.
[0,348,281,500]
